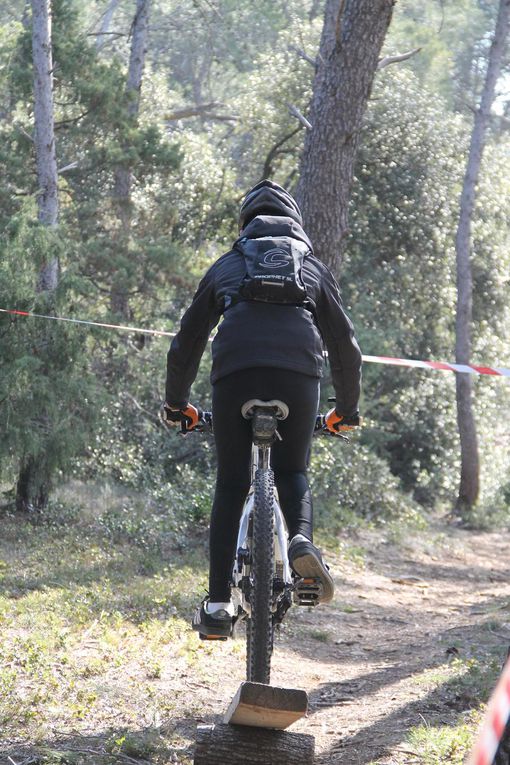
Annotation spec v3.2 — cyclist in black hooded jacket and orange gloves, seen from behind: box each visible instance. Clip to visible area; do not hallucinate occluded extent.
[163,180,361,636]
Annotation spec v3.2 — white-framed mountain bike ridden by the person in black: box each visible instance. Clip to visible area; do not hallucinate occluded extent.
[192,399,349,684]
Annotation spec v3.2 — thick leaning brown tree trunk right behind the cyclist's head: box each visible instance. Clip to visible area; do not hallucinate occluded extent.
[297,0,394,270]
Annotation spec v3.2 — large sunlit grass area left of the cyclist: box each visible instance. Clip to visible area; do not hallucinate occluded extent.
[0,484,217,763]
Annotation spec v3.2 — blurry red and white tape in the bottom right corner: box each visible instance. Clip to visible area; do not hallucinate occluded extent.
[466,661,510,765]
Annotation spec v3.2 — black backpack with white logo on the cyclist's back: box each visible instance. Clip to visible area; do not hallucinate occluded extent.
[233,236,310,305]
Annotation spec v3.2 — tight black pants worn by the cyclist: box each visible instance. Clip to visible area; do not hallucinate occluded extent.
[209,367,319,602]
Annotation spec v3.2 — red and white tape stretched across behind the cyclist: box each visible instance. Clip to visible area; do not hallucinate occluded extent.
[0,308,510,377]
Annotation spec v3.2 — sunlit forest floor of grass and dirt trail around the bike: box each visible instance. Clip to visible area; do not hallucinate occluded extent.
[0,486,510,765]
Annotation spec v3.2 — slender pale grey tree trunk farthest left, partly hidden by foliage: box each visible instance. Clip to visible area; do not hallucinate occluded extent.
[16,0,60,511]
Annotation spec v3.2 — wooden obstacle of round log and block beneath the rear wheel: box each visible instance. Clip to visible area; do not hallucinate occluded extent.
[194,682,315,765]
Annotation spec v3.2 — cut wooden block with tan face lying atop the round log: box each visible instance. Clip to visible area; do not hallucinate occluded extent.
[223,682,308,730]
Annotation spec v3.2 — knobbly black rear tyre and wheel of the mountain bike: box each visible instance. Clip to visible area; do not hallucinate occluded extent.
[246,470,274,684]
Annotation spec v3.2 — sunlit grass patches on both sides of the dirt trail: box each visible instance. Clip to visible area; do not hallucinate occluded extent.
[0,485,508,765]
